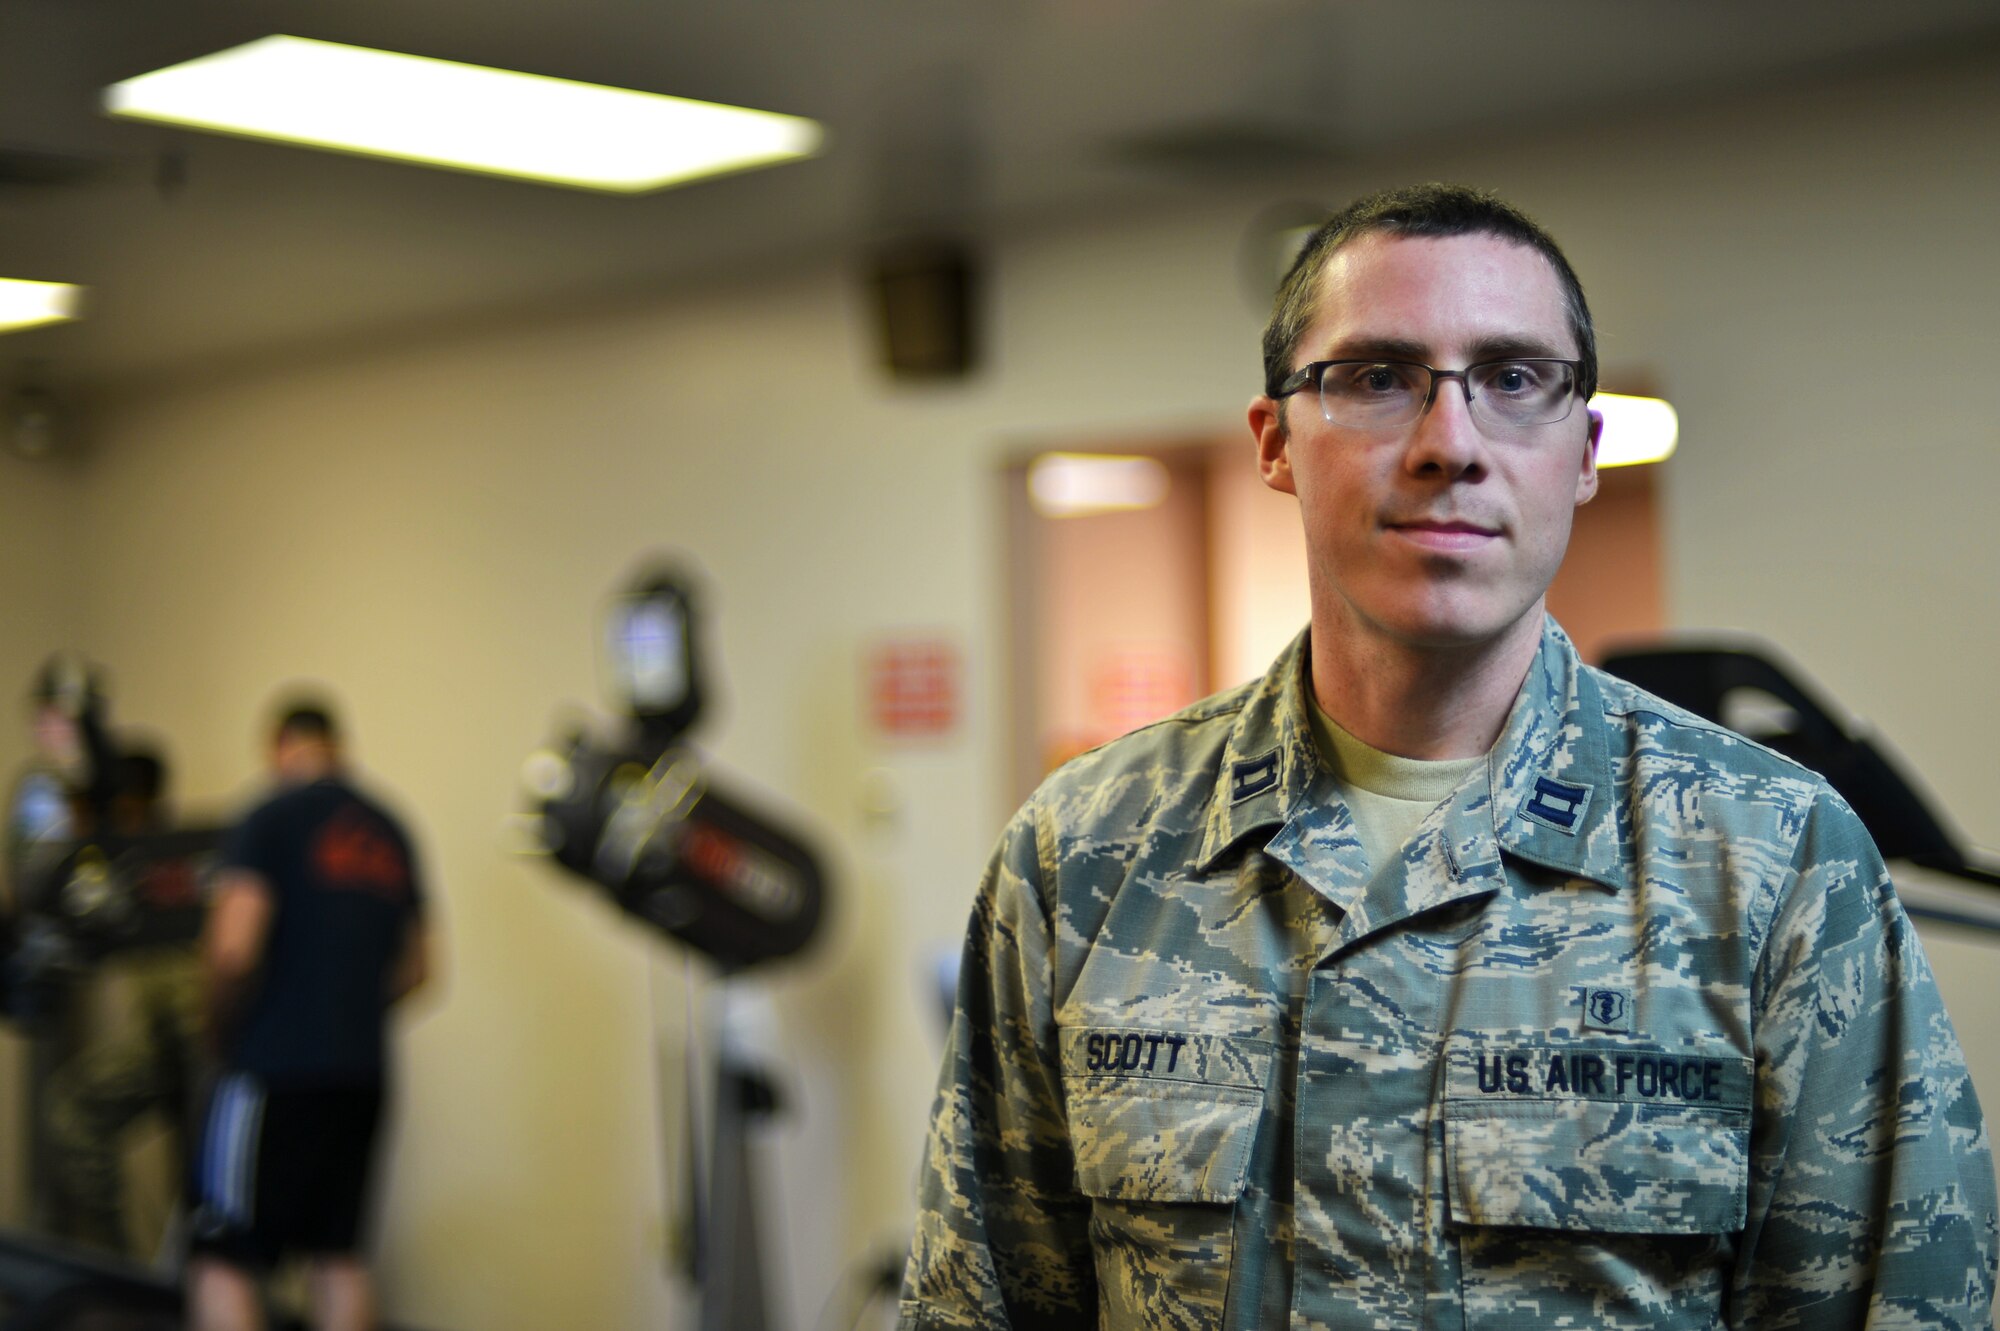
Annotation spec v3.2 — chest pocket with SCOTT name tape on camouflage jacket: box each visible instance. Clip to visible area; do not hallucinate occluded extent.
[1062,1027,1270,1329]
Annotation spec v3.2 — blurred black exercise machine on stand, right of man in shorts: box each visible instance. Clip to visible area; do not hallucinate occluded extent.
[522,566,826,1331]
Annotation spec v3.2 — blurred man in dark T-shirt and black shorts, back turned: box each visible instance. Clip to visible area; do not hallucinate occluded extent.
[188,701,430,1331]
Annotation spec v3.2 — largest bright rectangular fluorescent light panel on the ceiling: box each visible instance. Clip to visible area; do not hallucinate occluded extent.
[104,36,820,194]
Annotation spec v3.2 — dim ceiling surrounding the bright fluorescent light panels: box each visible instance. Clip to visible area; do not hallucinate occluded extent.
[0,0,2000,394]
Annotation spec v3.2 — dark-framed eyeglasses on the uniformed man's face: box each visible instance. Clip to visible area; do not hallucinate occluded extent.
[1272,356,1580,430]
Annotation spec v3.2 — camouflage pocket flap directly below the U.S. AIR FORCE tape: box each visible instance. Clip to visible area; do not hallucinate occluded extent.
[1444,1099,1750,1233]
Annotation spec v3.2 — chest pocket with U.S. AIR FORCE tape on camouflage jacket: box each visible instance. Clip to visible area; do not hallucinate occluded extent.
[1442,1047,1750,1329]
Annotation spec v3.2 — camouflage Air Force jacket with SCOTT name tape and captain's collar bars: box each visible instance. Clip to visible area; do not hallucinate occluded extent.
[902,624,1996,1331]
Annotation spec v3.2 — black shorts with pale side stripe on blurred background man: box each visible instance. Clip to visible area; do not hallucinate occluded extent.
[188,1073,382,1271]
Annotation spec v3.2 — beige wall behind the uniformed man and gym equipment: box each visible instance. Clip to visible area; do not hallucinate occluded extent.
[19,43,2000,1331]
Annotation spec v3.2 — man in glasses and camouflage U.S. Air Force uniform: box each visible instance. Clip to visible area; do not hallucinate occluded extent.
[902,186,1996,1331]
